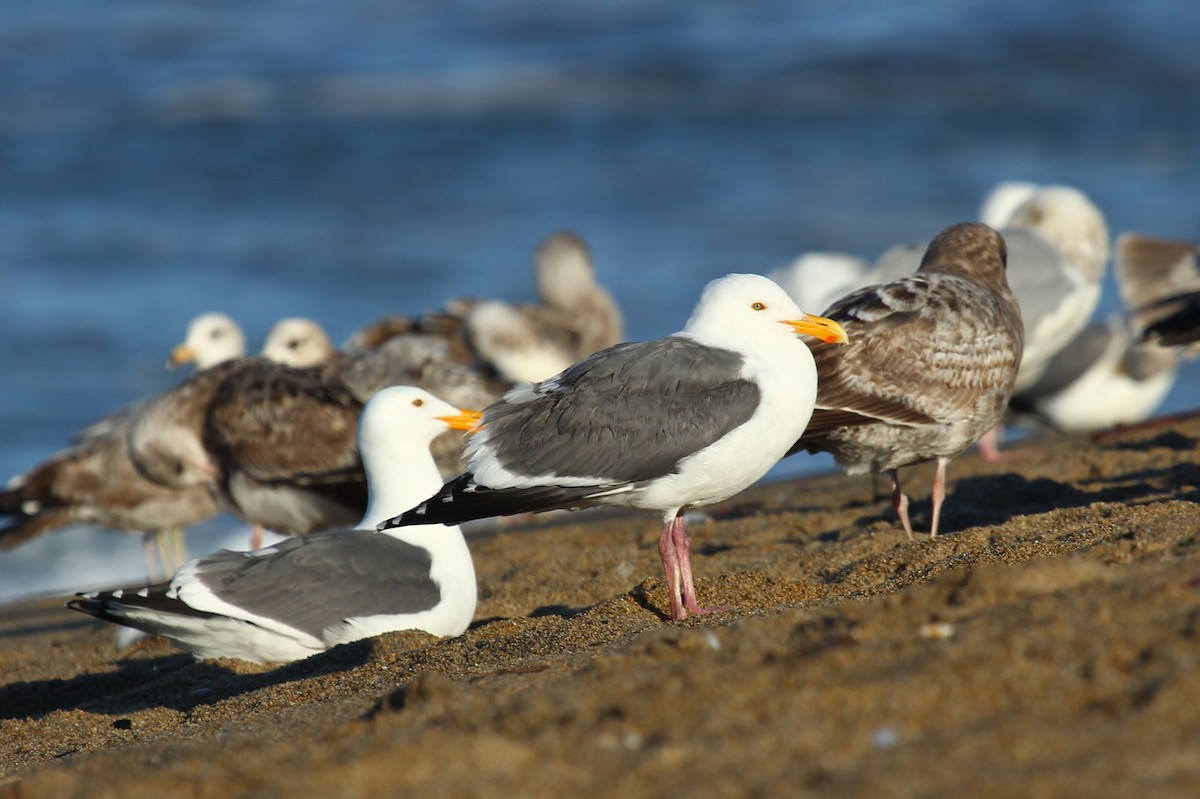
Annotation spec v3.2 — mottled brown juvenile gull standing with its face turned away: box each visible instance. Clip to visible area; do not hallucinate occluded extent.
[792,223,1022,539]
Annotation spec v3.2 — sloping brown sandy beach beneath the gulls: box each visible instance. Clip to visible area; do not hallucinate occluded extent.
[0,416,1200,799]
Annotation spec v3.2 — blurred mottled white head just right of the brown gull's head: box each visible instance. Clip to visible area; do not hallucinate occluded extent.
[1008,186,1109,283]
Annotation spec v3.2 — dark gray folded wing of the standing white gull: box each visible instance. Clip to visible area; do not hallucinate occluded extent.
[484,336,760,483]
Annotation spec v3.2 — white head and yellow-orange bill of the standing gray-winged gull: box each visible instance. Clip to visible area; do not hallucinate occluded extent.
[682,275,846,350]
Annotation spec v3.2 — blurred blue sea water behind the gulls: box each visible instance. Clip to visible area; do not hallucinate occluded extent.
[0,0,1200,600]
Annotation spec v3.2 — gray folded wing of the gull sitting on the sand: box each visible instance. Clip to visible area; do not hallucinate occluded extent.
[192,530,442,638]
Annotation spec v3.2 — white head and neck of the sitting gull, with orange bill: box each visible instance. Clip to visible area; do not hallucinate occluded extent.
[358,386,481,529]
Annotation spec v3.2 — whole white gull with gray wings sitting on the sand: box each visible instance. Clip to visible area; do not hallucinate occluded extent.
[67,386,479,662]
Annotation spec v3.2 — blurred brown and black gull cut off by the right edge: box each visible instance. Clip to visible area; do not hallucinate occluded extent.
[1117,233,1200,354]
